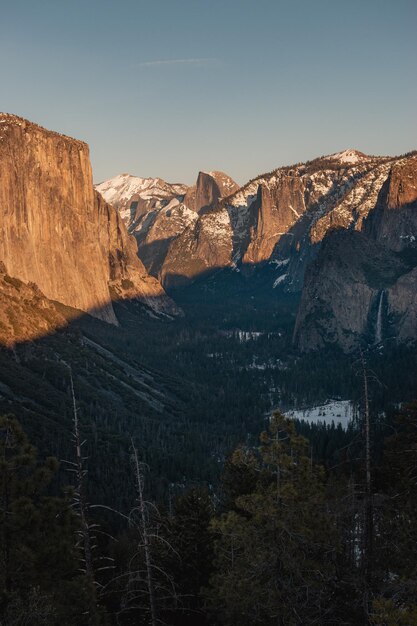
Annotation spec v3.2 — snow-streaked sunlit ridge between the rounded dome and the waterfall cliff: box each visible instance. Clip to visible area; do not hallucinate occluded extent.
[219,150,392,280]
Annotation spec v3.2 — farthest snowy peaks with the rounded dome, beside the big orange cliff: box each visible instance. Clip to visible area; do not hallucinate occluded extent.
[96,171,239,286]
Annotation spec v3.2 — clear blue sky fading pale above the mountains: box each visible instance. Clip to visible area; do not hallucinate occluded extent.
[0,0,417,183]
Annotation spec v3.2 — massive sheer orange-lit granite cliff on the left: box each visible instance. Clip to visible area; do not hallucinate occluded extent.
[0,114,175,323]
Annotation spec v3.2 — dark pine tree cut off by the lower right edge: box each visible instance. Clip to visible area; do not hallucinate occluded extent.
[371,402,417,626]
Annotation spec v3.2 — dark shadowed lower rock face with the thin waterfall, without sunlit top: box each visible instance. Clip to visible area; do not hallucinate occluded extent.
[294,224,417,352]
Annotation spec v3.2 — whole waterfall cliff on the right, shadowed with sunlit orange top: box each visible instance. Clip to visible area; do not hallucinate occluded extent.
[294,155,417,352]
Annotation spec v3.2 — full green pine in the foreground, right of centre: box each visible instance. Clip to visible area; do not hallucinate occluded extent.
[209,412,336,626]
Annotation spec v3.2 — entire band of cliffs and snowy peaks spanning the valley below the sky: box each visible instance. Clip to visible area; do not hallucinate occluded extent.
[0,114,417,351]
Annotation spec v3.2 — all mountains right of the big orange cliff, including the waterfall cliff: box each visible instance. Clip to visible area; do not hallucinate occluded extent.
[96,149,417,350]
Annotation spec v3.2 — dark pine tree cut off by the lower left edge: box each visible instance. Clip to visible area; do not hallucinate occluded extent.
[0,415,85,625]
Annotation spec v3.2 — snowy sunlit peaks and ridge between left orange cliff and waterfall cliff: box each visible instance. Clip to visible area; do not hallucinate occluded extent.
[98,150,396,292]
